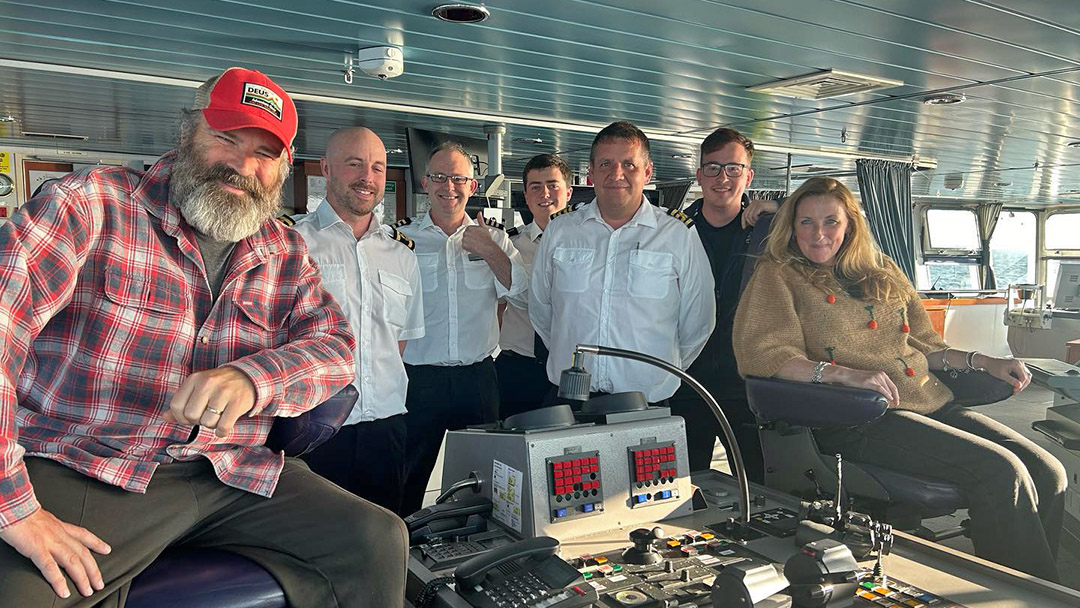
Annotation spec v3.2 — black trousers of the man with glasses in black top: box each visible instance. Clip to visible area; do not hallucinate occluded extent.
[670,387,765,484]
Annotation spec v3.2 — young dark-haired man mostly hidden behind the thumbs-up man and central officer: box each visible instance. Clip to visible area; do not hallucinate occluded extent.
[495,154,573,420]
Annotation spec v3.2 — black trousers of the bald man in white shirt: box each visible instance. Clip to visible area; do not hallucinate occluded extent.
[300,414,406,513]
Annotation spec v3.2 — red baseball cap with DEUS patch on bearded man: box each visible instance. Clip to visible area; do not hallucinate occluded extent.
[194,68,297,162]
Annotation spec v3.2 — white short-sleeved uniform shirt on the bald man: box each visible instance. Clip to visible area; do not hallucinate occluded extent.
[294,200,424,424]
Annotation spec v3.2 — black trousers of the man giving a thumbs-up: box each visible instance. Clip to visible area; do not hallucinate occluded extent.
[400,357,499,516]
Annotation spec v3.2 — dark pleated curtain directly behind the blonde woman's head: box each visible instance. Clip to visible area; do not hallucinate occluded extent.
[855,159,915,284]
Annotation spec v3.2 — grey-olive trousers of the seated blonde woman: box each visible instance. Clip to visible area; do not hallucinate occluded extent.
[814,405,1067,581]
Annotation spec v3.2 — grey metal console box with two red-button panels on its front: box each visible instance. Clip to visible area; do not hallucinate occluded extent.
[442,414,693,538]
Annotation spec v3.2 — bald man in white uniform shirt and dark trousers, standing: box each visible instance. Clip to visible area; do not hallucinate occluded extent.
[295,126,423,513]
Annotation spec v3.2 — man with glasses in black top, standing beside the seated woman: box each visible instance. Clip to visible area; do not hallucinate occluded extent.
[671,129,778,482]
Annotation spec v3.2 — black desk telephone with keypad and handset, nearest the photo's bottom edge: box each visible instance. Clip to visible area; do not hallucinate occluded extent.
[454,537,599,608]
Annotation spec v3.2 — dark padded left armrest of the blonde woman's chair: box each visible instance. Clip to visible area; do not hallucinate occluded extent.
[746,376,889,428]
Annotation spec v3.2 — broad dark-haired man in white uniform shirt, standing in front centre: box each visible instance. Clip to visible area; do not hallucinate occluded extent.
[529,122,716,403]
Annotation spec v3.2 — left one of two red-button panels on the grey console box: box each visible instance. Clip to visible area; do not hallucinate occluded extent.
[546,451,604,522]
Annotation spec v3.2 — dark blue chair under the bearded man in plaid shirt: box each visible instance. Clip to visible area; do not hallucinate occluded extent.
[126,386,359,608]
